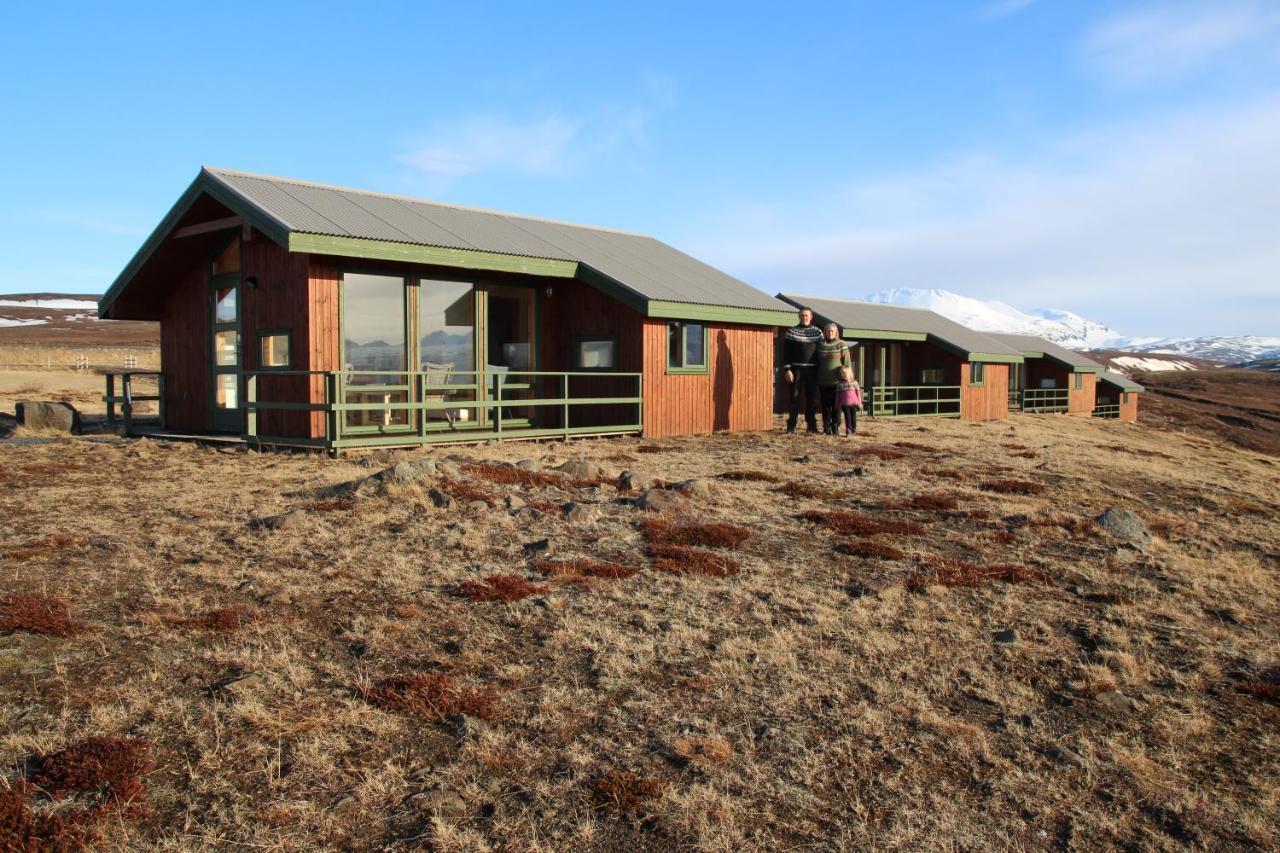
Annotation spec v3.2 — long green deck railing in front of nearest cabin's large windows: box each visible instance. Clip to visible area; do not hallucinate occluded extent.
[243,370,644,450]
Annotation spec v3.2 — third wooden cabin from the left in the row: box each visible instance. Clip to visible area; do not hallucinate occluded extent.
[989,332,1102,418]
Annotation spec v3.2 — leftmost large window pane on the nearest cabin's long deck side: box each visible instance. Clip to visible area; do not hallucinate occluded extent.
[342,273,407,376]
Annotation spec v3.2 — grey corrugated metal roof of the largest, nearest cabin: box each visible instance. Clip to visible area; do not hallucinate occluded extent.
[205,168,790,311]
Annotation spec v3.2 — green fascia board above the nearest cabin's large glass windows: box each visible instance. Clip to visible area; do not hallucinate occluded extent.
[288,232,577,278]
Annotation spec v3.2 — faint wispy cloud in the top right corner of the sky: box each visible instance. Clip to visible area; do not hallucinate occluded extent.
[1080,0,1280,86]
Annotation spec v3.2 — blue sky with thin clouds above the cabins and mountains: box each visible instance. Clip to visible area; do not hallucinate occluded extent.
[0,0,1280,336]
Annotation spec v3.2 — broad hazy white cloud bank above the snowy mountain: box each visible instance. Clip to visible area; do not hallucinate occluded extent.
[698,99,1280,336]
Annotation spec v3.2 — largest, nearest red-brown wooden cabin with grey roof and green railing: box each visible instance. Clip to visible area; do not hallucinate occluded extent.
[99,168,794,450]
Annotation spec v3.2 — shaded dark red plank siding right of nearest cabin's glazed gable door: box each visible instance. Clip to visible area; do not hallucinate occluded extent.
[241,233,311,438]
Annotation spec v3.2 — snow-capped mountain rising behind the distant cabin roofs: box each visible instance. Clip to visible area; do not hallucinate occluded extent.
[863,287,1132,350]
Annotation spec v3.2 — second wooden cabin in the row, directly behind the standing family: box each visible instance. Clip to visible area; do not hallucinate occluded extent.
[778,293,1023,420]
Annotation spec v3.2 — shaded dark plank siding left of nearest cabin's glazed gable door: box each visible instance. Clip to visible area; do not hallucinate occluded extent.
[160,261,212,432]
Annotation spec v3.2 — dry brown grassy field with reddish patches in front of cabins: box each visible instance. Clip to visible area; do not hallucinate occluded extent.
[0,404,1280,850]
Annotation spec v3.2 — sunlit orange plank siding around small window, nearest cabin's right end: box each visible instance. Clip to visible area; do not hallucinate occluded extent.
[644,319,774,438]
